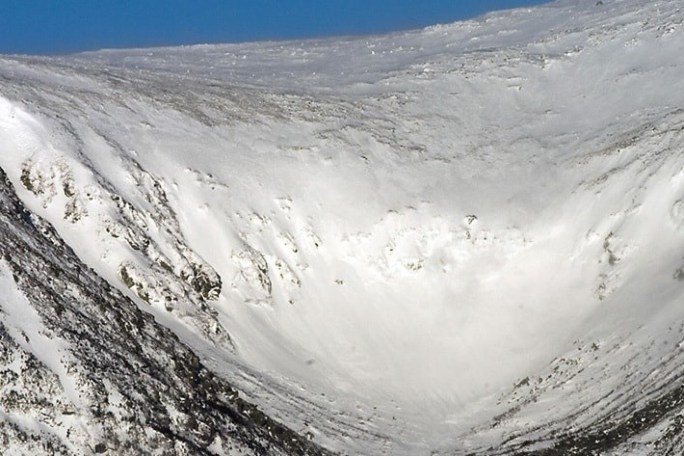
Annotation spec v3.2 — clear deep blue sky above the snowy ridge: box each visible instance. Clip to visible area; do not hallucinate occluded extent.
[0,0,546,54]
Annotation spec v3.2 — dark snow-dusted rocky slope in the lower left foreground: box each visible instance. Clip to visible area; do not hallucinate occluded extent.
[0,166,328,455]
